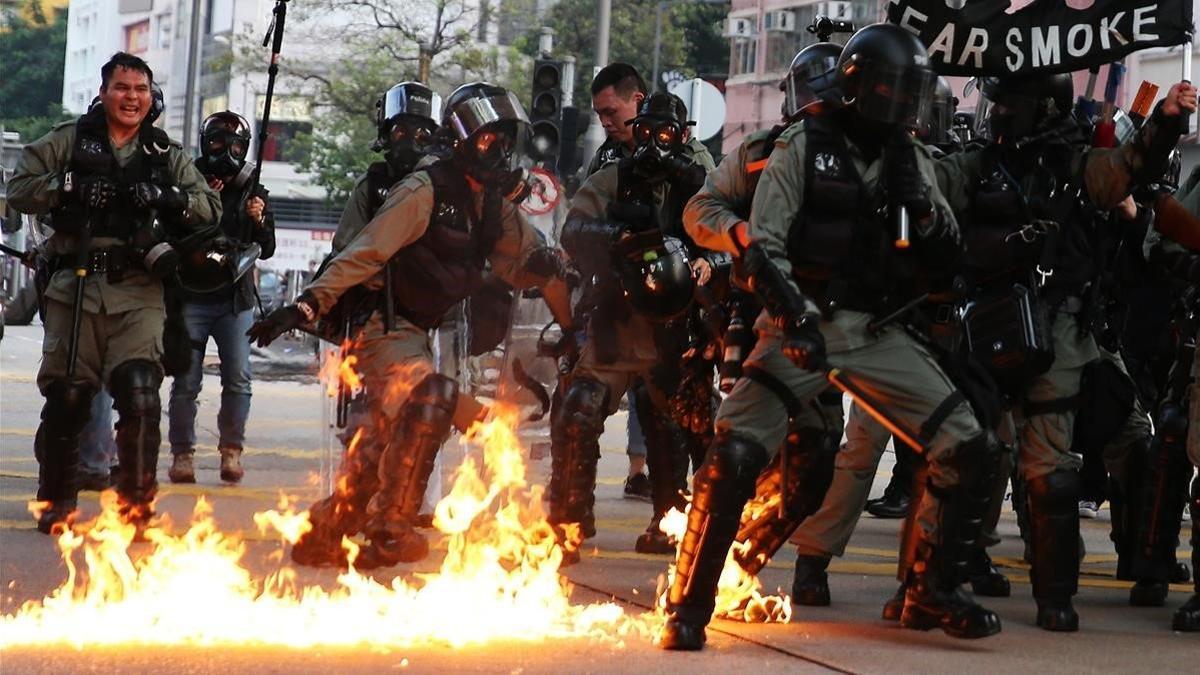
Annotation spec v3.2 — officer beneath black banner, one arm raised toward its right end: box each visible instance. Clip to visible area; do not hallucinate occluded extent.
[938,73,1195,631]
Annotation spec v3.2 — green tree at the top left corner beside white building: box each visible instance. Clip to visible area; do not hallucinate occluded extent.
[0,0,70,141]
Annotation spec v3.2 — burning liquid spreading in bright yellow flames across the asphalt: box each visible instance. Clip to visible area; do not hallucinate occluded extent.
[0,398,790,649]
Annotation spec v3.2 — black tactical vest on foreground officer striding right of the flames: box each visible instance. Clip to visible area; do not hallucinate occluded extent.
[787,118,899,311]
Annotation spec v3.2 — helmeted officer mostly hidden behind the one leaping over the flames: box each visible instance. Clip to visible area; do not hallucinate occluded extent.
[283,82,442,566]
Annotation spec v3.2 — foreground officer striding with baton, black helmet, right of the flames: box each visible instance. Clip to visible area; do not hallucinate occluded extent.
[660,24,1000,650]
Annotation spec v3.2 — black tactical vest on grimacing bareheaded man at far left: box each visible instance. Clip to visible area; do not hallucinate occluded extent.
[54,106,174,241]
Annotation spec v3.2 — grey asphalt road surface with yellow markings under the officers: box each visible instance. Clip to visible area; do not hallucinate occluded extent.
[0,325,1200,674]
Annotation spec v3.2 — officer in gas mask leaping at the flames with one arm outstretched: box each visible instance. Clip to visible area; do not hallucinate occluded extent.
[250,83,571,567]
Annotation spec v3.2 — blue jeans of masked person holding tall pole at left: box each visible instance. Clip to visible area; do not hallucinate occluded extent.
[168,299,254,455]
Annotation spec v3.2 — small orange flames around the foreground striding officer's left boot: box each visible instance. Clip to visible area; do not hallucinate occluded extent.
[658,504,792,623]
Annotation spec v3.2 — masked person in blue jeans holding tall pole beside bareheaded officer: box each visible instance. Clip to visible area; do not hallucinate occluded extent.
[167,110,275,483]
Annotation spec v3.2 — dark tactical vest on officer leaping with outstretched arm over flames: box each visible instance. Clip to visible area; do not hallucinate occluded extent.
[390,160,503,330]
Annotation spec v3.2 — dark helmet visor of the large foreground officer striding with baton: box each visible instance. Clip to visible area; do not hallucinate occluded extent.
[850,61,937,130]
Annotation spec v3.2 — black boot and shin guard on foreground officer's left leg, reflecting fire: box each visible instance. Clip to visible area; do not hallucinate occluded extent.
[659,434,767,651]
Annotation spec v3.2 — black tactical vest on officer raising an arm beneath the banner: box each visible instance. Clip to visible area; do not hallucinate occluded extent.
[964,144,1097,294]
